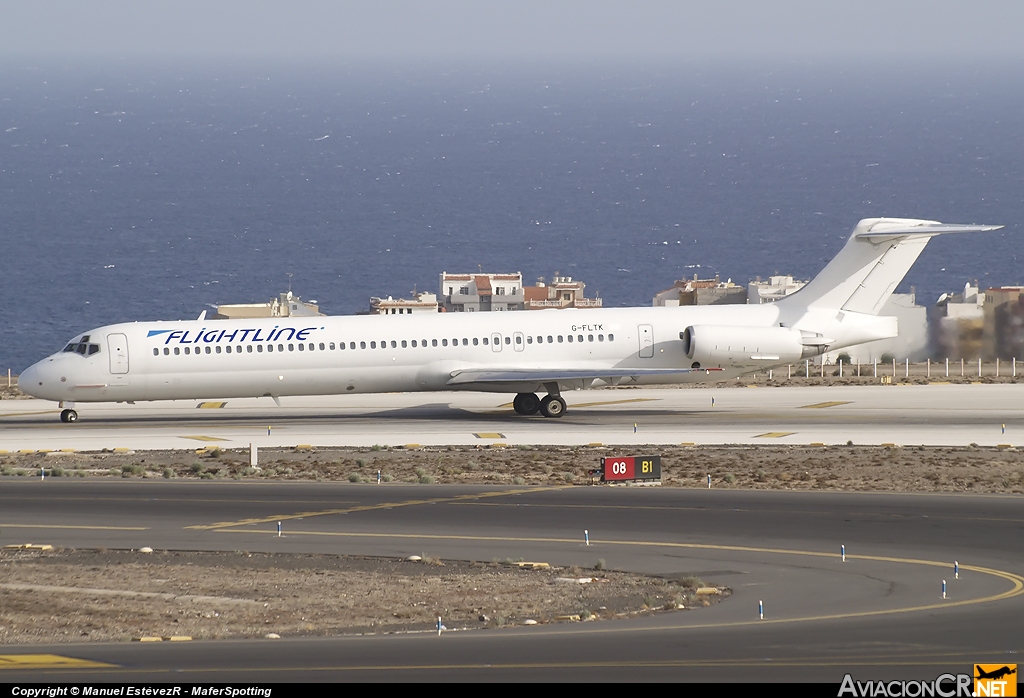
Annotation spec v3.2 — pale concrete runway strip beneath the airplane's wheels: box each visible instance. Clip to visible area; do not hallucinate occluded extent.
[0,384,1024,451]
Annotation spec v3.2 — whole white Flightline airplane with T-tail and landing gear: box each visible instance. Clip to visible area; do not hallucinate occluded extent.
[19,218,1002,423]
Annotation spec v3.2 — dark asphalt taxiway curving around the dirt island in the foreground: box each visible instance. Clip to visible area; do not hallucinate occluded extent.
[0,478,1024,684]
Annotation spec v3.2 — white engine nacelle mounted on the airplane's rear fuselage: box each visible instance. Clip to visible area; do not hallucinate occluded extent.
[679,324,821,367]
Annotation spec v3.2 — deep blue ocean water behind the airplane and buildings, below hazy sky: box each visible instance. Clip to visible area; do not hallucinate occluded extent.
[0,59,1024,372]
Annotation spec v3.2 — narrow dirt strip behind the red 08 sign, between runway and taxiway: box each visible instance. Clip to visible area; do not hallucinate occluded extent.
[0,445,1024,493]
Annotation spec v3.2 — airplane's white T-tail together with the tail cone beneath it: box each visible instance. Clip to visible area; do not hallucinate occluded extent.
[777,218,1002,352]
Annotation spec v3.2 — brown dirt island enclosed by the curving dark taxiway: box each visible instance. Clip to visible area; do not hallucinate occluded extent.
[0,550,729,644]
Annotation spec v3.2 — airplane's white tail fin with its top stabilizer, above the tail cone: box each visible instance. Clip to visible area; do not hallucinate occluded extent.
[778,218,1002,315]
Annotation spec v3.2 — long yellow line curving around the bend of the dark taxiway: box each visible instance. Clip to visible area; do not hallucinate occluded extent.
[221,529,1024,635]
